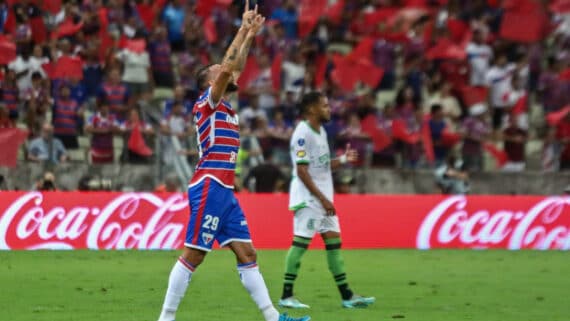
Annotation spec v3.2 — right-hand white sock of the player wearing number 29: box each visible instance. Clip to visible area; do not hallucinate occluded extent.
[238,262,279,321]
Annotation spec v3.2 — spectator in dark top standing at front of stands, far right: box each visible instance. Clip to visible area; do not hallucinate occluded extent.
[503,114,528,172]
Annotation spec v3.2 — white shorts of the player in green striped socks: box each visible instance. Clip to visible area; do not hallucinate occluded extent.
[293,207,340,239]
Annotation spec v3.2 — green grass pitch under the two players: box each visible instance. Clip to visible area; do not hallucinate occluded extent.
[0,250,570,321]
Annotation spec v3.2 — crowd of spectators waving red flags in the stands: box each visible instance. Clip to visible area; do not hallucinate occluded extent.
[0,0,570,182]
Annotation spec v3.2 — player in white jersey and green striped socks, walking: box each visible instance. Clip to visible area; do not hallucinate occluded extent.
[279,92,375,308]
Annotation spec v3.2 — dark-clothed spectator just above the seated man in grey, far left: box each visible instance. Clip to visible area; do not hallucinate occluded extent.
[22,72,53,136]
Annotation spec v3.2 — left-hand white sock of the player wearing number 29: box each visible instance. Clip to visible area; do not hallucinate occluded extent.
[158,257,194,321]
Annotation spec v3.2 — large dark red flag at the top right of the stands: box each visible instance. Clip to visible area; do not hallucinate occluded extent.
[499,11,547,43]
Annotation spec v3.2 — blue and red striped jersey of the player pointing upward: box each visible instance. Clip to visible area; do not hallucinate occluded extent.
[190,87,240,188]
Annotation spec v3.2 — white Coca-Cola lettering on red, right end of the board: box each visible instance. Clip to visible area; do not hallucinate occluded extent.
[416,196,570,250]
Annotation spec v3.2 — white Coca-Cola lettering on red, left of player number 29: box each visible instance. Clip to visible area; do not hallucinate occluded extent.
[0,192,188,249]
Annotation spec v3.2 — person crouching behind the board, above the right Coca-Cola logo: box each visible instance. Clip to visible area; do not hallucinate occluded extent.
[434,155,470,194]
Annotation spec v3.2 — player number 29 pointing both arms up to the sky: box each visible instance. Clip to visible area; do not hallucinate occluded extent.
[154,0,310,321]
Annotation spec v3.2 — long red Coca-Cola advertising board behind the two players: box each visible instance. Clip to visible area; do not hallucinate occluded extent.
[0,192,570,250]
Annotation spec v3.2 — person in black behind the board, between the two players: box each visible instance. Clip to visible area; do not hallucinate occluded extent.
[243,151,287,193]
